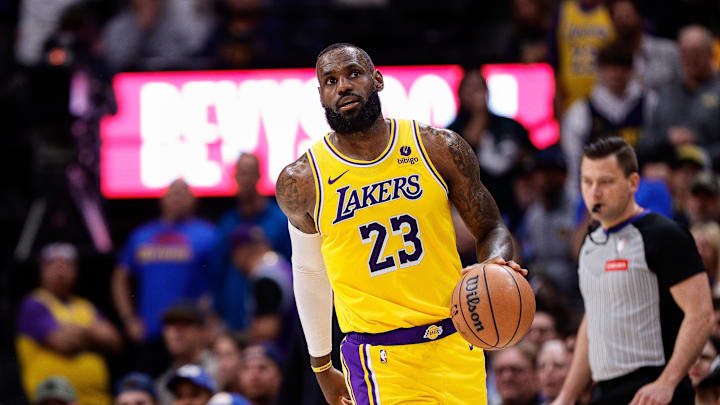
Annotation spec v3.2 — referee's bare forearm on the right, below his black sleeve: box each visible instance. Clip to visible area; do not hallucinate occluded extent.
[630,272,713,405]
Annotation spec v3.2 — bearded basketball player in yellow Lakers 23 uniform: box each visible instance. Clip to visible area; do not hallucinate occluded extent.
[276,44,527,405]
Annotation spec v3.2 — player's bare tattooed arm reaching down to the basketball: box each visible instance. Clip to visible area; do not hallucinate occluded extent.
[420,126,519,268]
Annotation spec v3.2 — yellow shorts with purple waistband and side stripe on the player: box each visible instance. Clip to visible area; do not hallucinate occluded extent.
[340,318,487,405]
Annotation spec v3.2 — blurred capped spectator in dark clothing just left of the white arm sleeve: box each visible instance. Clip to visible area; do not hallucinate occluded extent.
[230,225,298,350]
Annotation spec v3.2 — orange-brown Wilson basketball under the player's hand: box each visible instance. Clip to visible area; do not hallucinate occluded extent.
[450,264,535,350]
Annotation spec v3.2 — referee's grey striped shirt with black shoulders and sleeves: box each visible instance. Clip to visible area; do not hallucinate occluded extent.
[578,210,703,381]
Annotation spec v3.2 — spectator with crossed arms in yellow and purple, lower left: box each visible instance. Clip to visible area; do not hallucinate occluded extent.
[16,243,122,405]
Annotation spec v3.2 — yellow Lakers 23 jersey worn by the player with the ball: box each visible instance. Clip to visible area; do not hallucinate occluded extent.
[307,120,461,333]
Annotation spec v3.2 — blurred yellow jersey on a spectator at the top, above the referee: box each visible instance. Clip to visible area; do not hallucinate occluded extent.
[557,0,613,108]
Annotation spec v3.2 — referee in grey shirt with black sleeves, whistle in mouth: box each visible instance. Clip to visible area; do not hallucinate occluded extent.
[553,137,713,405]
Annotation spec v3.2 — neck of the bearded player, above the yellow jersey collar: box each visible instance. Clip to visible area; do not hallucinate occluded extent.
[330,115,390,160]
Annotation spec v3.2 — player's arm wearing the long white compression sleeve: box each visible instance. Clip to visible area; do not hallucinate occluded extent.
[275,155,351,405]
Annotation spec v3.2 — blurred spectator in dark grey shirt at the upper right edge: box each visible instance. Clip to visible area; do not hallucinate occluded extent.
[640,25,720,158]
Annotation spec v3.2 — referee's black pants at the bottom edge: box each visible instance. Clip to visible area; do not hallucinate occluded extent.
[590,367,695,405]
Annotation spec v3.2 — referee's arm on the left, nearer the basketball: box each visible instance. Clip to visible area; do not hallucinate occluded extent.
[552,315,591,405]
